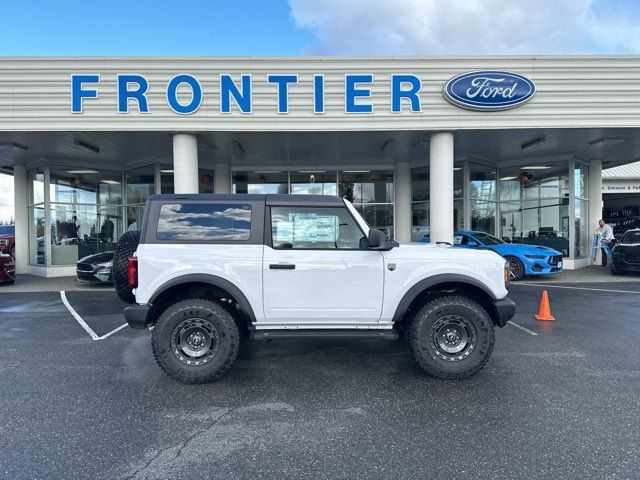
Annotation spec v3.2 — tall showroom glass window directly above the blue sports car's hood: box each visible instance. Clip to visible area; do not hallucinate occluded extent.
[498,162,569,256]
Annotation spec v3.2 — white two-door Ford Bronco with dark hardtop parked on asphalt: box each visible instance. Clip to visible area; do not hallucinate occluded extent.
[114,194,515,383]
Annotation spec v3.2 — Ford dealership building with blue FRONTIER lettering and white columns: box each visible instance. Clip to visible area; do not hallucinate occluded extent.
[0,56,640,276]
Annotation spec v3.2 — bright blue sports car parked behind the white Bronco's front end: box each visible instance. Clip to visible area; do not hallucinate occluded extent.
[421,231,562,280]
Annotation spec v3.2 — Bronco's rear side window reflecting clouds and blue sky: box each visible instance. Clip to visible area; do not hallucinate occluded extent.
[156,203,251,241]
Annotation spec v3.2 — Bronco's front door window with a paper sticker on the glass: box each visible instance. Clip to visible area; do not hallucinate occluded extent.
[271,207,364,250]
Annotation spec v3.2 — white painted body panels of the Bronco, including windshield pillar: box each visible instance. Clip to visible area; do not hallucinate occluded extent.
[135,202,507,329]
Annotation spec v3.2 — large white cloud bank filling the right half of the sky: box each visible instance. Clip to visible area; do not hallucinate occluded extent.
[289,0,640,55]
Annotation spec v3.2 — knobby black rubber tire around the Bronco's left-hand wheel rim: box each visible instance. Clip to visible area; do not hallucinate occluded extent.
[151,299,240,383]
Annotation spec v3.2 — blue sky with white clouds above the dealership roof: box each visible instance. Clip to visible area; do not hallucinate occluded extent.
[0,0,640,220]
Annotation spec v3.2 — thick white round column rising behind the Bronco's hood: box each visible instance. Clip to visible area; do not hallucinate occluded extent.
[429,132,453,243]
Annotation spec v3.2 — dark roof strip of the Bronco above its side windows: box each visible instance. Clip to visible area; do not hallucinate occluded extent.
[148,193,344,207]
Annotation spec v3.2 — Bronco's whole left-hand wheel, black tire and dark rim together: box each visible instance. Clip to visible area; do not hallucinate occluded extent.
[151,299,240,383]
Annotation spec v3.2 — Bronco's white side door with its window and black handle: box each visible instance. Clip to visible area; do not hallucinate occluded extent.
[263,205,384,328]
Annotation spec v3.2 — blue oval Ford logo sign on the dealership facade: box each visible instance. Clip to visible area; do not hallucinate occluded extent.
[443,70,536,110]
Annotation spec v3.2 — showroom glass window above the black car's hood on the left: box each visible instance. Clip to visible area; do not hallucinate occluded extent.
[45,165,123,265]
